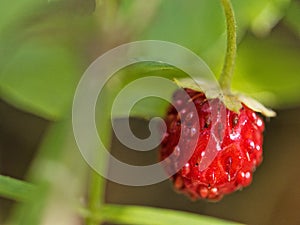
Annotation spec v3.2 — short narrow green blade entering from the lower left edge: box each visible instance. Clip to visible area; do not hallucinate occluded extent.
[0,175,36,201]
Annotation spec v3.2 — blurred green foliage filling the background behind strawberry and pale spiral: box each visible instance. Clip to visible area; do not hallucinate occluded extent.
[0,0,300,225]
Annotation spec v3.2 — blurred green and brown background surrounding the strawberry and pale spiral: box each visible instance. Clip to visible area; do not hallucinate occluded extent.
[0,0,300,225]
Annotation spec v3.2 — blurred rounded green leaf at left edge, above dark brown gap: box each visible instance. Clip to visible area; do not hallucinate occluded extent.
[0,42,78,119]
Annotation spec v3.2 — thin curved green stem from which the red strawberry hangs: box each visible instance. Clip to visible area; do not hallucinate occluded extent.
[219,0,237,93]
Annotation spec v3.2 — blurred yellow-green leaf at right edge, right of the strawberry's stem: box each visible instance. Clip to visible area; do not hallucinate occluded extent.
[233,30,300,108]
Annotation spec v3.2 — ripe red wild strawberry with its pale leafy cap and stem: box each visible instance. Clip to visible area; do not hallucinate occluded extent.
[160,0,275,201]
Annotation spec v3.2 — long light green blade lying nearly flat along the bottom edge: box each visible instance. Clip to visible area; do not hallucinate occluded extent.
[81,204,244,225]
